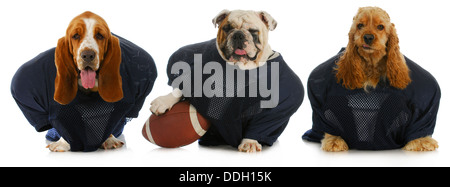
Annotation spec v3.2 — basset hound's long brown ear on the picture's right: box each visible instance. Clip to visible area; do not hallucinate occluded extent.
[98,35,123,102]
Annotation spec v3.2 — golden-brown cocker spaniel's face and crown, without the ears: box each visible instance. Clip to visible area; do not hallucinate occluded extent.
[351,7,391,56]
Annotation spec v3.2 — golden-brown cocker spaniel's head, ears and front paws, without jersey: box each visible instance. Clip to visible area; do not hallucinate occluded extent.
[322,7,438,151]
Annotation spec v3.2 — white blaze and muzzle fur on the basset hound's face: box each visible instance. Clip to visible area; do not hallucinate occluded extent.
[77,18,100,70]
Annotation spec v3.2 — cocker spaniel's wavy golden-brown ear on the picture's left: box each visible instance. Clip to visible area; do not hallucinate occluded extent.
[335,29,366,90]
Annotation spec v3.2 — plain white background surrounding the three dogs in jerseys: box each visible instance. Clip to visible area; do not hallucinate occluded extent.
[0,0,450,166]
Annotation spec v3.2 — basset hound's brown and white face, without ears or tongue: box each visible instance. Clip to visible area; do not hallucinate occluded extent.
[66,12,110,71]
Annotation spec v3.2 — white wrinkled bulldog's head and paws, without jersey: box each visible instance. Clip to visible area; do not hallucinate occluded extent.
[150,10,279,152]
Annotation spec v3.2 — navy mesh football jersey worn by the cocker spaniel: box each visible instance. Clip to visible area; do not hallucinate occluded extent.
[303,49,441,150]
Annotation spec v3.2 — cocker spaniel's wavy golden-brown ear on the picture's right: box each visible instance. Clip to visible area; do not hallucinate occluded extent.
[386,23,411,89]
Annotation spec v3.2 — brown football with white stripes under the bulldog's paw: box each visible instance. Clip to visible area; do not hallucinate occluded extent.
[142,101,211,148]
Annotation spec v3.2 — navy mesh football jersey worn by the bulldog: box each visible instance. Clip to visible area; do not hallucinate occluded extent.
[167,39,304,147]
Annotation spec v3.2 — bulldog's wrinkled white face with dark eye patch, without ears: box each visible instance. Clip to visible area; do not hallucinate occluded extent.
[217,11,268,63]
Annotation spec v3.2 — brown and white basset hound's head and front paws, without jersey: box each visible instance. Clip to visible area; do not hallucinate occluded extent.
[47,11,124,152]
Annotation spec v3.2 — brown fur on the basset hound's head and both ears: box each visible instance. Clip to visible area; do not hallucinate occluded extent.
[54,12,123,105]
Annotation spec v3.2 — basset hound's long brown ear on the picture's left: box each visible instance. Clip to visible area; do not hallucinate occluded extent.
[53,37,78,105]
